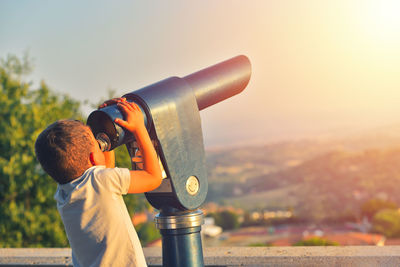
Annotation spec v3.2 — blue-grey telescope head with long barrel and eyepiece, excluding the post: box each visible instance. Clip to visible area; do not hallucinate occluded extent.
[88,56,251,214]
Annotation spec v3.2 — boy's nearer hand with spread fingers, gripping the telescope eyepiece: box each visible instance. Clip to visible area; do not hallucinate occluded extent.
[115,100,145,134]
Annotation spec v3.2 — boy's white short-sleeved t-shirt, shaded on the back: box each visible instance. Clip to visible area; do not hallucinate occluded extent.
[54,166,147,267]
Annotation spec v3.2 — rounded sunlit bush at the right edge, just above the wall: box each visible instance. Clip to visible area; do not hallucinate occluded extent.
[372,209,400,237]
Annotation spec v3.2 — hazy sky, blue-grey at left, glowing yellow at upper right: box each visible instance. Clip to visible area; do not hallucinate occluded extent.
[0,0,400,147]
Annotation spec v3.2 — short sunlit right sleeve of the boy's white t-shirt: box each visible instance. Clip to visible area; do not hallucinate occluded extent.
[95,168,131,195]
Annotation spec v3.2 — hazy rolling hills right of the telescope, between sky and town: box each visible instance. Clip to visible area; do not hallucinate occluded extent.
[207,125,400,222]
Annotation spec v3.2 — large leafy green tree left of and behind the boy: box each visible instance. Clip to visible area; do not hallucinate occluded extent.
[0,56,82,247]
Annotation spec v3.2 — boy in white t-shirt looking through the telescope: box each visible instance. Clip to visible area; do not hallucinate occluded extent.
[35,98,161,267]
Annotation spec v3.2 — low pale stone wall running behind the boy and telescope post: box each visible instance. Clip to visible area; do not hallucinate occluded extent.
[0,246,400,267]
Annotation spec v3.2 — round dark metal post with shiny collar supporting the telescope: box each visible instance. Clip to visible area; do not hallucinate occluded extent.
[155,210,204,267]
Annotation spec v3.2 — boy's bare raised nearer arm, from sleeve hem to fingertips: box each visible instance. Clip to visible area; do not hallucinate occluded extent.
[115,101,162,193]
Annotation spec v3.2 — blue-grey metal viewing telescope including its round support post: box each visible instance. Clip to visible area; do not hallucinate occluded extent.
[87,56,251,267]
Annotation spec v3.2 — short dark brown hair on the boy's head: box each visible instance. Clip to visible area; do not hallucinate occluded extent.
[35,120,93,184]
